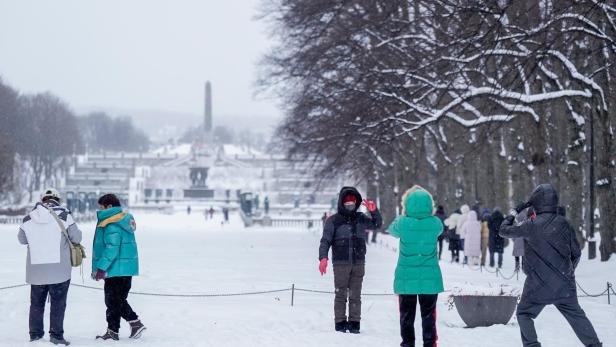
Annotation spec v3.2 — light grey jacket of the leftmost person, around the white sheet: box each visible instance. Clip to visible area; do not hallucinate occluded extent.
[17,200,81,285]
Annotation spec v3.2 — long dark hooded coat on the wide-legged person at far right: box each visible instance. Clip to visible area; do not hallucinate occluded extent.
[500,184,581,304]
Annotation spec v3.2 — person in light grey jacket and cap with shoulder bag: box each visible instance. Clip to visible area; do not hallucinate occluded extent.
[17,188,81,346]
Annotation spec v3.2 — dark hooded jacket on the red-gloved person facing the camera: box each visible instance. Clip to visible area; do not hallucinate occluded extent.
[319,187,383,264]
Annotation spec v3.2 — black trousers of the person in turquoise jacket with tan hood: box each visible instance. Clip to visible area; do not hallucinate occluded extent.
[105,277,139,333]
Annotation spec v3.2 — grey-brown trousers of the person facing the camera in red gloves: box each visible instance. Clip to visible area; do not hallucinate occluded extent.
[334,264,365,323]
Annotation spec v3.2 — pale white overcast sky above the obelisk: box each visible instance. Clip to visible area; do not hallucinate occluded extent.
[0,0,281,137]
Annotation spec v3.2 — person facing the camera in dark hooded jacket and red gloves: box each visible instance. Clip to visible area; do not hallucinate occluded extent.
[319,187,383,334]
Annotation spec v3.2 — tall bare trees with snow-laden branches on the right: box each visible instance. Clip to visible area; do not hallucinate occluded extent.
[261,0,616,260]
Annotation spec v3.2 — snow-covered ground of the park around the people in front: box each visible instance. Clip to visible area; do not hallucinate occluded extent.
[0,213,616,347]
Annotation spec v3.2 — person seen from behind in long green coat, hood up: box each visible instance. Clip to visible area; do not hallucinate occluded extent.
[387,186,444,347]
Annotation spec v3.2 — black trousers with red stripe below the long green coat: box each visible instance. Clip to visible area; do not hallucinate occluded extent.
[399,294,438,347]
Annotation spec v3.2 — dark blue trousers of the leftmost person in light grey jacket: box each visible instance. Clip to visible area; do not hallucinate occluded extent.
[30,280,71,340]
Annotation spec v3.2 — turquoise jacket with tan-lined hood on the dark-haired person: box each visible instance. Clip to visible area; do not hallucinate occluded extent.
[92,207,139,277]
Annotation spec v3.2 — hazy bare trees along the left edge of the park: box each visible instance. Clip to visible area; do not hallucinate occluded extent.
[0,80,149,202]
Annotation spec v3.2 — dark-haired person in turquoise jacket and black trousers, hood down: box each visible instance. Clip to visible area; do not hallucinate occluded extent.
[92,194,145,340]
